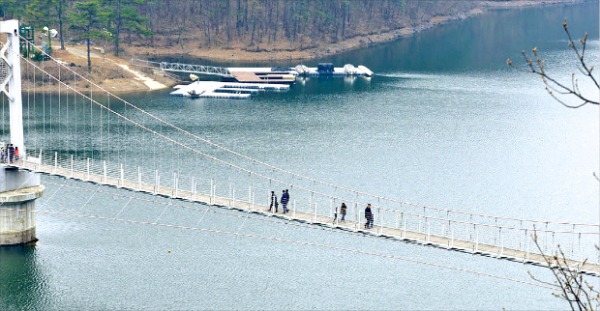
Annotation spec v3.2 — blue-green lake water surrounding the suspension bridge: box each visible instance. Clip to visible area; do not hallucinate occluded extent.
[0,2,600,310]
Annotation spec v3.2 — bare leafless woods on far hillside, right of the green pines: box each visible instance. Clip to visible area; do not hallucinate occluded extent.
[144,0,475,50]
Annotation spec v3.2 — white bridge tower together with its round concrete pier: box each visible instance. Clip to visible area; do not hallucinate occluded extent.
[0,20,44,246]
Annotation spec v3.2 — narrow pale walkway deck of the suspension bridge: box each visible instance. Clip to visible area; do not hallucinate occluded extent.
[13,161,600,276]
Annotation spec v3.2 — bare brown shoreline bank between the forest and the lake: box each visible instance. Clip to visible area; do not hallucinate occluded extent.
[22,0,594,94]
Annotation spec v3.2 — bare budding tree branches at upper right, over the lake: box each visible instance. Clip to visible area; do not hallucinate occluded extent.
[506,20,600,108]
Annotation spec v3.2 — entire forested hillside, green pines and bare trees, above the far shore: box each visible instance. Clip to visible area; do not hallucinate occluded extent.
[0,0,584,60]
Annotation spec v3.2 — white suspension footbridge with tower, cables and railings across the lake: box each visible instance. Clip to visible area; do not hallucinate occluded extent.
[0,22,600,276]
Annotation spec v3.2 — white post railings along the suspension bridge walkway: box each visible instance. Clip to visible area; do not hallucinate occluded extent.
[22,153,598,272]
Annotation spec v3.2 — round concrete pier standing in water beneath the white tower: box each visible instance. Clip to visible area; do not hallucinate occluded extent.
[0,166,44,246]
